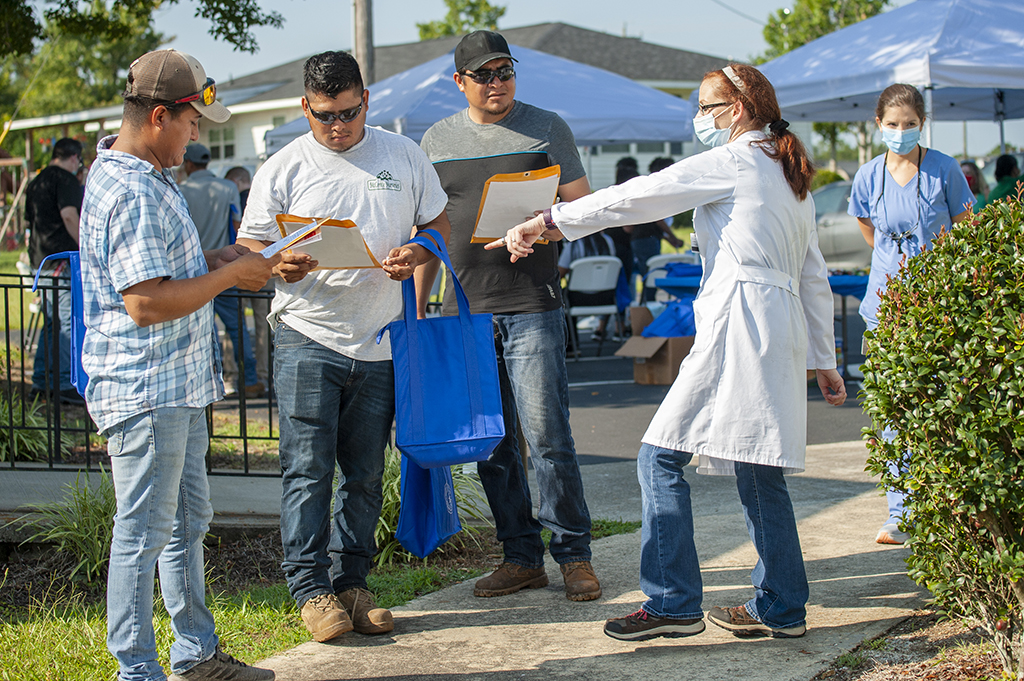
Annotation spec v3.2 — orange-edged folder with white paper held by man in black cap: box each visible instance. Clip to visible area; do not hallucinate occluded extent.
[471,166,562,244]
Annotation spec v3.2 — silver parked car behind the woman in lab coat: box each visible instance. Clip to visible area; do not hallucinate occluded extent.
[811,181,871,269]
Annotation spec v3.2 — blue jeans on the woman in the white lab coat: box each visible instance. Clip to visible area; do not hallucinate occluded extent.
[637,444,808,628]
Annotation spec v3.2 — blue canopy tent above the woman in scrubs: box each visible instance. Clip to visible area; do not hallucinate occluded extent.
[759,0,1024,148]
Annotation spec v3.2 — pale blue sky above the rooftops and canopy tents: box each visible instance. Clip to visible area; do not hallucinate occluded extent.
[149,0,1024,155]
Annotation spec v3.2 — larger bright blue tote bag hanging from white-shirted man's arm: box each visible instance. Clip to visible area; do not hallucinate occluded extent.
[377,229,505,468]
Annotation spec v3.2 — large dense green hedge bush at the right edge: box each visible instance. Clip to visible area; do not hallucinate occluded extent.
[863,195,1024,679]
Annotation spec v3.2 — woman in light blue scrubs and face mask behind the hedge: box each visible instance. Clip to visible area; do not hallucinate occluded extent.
[849,84,975,544]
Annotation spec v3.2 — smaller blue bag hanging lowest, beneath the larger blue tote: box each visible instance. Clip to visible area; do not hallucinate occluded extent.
[394,457,462,558]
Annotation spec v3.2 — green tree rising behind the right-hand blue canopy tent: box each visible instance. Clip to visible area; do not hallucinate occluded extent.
[757,0,890,170]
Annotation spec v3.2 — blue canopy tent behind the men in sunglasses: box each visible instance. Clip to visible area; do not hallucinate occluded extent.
[264,45,693,155]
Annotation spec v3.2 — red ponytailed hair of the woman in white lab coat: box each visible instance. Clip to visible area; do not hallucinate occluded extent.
[705,63,814,201]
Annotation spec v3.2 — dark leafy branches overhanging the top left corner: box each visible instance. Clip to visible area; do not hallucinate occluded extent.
[0,0,284,57]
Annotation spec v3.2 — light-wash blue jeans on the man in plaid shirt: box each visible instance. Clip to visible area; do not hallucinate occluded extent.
[104,408,217,681]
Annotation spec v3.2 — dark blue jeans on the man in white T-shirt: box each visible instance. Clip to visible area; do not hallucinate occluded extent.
[273,324,394,606]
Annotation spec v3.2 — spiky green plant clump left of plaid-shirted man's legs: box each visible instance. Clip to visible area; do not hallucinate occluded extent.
[21,469,118,582]
